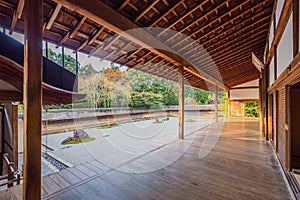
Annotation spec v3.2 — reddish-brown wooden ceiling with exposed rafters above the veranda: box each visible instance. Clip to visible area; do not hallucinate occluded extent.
[0,0,274,90]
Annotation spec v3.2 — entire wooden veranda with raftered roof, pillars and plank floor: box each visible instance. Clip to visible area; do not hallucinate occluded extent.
[0,0,300,200]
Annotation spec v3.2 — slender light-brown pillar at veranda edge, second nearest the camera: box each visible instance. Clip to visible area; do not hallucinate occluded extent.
[178,66,184,140]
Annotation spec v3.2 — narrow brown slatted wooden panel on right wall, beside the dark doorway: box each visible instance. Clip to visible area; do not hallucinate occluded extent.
[277,88,287,166]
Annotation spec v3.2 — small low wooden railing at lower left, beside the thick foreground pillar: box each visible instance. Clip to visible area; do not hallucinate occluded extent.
[0,153,23,188]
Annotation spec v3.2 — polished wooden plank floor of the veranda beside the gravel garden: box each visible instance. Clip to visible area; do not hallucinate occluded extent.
[0,121,291,200]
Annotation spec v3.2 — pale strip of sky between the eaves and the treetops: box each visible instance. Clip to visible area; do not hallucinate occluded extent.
[0,28,127,71]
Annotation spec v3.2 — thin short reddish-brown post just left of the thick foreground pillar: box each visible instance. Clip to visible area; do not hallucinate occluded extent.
[12,105,18,170]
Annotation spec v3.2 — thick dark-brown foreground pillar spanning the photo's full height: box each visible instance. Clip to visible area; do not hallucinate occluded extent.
[23,0,43,200]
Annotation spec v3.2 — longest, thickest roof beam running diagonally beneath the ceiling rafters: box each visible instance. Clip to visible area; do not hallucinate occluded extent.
[54,0,228,90]
